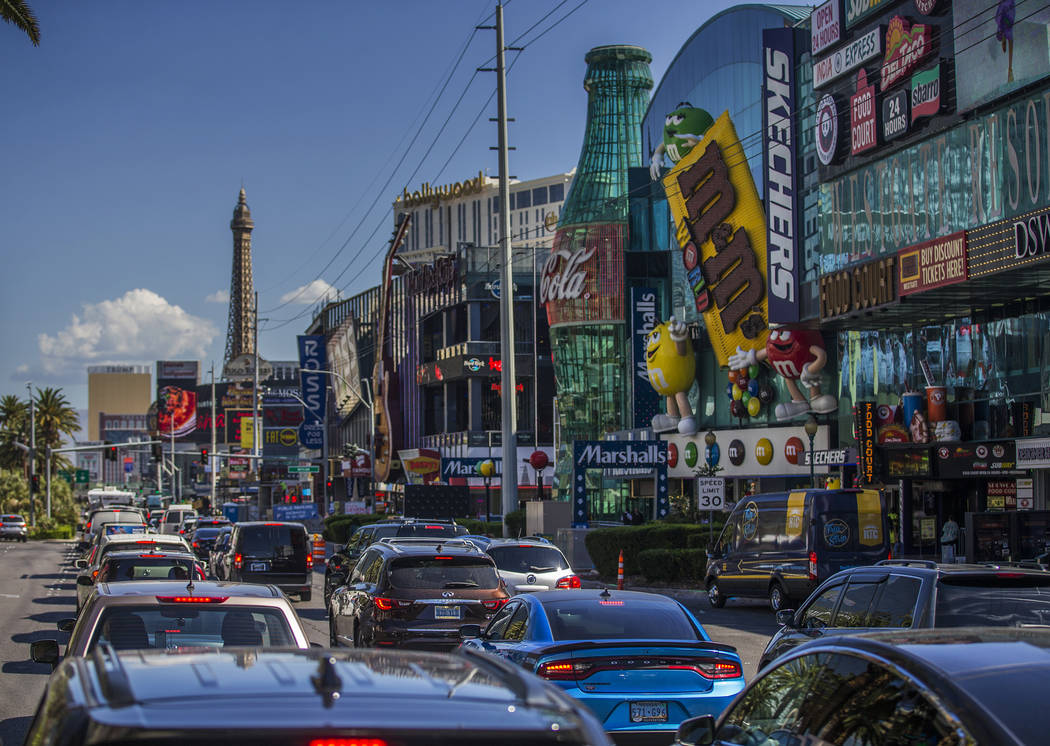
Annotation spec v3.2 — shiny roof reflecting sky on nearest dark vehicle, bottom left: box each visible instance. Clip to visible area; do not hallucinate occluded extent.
[56,648,606,743]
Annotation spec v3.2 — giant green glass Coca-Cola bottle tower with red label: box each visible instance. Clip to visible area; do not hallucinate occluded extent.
[540,45,653,495]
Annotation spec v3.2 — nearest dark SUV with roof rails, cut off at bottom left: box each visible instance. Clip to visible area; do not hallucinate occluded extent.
[26,644,612,746]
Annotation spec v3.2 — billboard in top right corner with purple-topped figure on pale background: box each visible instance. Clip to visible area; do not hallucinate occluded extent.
[952,0,1050,111]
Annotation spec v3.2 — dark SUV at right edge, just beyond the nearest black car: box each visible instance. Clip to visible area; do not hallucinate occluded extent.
[758,560,1050,669]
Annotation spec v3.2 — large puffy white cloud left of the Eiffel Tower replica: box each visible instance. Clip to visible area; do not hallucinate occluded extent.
[38,288,218,375]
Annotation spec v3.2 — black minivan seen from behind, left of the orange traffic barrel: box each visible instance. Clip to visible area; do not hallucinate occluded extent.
[222,521,314,601]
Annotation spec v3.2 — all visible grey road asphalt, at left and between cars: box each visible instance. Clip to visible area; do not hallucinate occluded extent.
[0,541,776,746]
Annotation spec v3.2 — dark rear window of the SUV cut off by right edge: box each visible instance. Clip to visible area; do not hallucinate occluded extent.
[935,572,1050,627]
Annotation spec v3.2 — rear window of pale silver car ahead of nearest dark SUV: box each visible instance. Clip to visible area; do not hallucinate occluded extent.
[88,605,296,650]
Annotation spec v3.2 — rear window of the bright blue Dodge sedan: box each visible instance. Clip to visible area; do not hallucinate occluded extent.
[543,596,699,640]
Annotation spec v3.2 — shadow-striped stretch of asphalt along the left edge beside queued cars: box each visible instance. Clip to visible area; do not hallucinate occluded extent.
[0,541,77,744]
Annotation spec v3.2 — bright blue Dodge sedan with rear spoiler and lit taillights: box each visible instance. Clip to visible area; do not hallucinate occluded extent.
[460,589,744,743]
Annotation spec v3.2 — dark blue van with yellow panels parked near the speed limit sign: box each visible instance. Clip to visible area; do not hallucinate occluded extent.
[705,490,890,612]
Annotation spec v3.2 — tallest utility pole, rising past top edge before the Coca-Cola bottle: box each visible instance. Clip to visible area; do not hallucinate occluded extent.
[479,3,518,536]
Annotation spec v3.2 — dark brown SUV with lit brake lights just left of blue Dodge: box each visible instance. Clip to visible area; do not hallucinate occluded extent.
[329,537,509,650]
